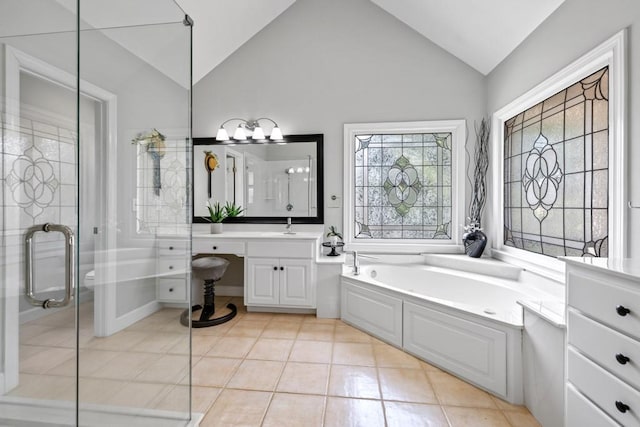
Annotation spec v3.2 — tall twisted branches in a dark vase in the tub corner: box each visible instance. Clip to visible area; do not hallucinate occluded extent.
[462,118,491,258]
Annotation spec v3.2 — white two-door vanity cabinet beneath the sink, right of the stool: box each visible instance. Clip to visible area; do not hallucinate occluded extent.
[245,240,316,308]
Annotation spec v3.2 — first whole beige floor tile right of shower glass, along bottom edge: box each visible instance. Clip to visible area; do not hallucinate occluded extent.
[200,389,272,427]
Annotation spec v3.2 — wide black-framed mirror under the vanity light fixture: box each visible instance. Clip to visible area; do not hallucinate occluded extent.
[192,134,324,224]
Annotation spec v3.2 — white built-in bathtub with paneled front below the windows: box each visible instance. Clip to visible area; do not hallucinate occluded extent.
[341,256,544,404]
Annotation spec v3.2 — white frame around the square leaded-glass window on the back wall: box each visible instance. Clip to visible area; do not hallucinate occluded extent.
[343,120,466,253]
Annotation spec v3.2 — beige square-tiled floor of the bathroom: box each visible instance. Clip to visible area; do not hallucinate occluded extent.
[11,297,539,427]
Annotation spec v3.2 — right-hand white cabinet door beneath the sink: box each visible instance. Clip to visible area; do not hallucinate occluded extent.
[280,258,316,308]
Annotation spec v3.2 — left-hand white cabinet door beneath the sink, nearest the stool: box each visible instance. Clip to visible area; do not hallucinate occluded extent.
[247,258,280,305]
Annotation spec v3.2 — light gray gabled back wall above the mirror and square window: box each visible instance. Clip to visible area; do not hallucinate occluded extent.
[193,0,485,236]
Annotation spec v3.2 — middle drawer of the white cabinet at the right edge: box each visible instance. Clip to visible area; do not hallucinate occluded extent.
[567,309,640,392]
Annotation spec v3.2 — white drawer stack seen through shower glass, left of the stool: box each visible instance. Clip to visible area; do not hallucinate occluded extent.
[156,237,191,303]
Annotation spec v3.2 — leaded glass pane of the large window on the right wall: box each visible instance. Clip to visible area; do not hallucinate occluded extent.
[504,67,609,257]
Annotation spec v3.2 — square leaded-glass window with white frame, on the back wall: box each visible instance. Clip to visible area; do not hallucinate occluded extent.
[345,121,464,249]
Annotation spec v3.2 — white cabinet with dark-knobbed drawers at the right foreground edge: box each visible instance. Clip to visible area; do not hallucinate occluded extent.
[566,259,640,427]
